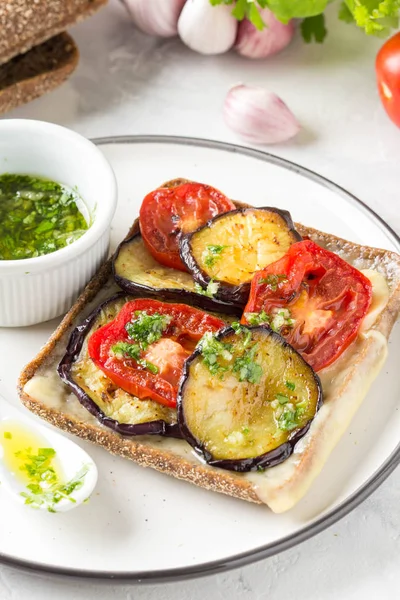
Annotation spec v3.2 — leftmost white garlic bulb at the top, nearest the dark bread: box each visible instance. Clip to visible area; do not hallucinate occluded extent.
[122,0,186,37]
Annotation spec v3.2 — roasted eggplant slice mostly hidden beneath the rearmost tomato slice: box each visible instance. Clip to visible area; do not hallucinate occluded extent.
[113,233,241,315]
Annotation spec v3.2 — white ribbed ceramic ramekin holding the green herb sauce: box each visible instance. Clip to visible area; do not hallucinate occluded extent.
[0,119,117,327]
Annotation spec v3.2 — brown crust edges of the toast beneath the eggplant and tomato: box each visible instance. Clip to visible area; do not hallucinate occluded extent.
[18,180,400,512]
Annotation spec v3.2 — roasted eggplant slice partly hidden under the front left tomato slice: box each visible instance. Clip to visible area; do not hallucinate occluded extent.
[58,294,180,437]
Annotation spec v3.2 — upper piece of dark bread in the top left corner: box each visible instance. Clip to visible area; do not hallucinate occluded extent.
[0,0,107,64]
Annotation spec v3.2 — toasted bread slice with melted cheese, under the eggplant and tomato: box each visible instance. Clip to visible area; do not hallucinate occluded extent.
[18,180,400,512]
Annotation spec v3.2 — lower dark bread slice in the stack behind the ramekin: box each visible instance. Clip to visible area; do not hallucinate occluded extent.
[0,33,79,113]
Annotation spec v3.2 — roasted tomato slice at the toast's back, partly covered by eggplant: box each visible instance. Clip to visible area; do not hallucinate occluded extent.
[139,183,235,271]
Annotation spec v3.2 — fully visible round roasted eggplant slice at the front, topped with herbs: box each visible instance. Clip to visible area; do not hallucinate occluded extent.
[178,326,322,471]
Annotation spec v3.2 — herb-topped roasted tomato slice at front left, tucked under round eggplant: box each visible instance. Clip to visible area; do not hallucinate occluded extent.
[88,298,225,407]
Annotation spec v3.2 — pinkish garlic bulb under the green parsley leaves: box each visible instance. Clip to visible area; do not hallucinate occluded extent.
[235,8,295,58]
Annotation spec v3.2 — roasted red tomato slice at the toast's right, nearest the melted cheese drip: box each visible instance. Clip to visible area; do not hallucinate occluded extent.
[242,240,372,371]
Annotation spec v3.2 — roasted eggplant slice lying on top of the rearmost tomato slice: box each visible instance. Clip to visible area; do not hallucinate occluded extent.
[180,208,301,306]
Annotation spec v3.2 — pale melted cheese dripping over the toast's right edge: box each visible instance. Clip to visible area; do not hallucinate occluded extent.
[24,270,389,513]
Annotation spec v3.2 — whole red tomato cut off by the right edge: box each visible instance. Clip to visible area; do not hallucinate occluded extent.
[375,33,400,127]
